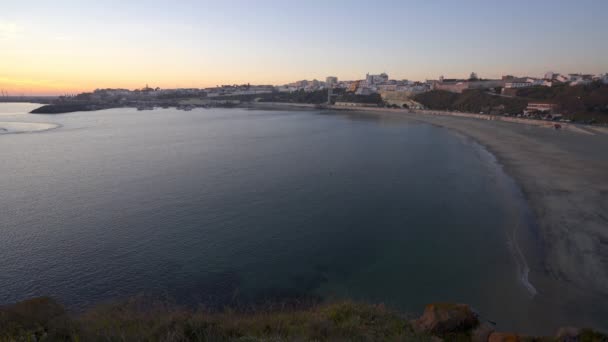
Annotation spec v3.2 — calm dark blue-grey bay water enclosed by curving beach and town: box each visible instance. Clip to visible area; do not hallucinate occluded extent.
[0,104,580,330]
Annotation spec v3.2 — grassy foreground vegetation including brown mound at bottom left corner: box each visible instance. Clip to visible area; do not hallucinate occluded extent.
[0,298,431,341]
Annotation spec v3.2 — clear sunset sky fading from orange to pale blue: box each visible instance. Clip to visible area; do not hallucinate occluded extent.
[0,0,608,95]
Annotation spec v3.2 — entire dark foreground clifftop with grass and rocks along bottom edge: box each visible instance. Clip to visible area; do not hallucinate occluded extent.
[0,297,608,342]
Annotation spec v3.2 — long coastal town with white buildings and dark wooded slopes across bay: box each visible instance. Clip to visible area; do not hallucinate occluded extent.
[17,72,608,124]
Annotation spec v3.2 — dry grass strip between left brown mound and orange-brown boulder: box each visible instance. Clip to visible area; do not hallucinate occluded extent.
[72,302,430,341]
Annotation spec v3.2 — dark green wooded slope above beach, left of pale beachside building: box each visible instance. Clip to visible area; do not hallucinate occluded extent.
[414,90,528,114]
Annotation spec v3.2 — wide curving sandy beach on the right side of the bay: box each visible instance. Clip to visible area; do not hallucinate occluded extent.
[356,109,608,297]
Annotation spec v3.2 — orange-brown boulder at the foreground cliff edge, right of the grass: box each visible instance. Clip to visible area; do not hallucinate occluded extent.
[413,303,479,334]
